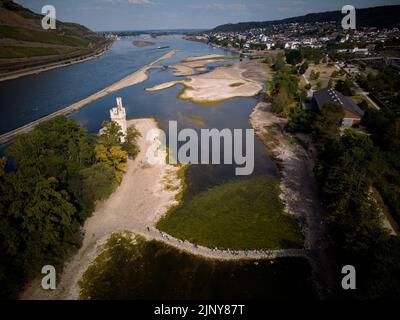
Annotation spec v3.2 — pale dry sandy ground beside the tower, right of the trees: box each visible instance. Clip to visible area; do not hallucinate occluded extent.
[20,119,180,299]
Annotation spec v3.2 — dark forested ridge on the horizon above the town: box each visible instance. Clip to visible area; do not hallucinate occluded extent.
[212,5,400,32]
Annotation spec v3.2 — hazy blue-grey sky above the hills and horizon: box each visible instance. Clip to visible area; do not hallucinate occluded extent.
[15,0,400,31]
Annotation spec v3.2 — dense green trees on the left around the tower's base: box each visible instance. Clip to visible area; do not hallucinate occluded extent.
[0,116,138,298]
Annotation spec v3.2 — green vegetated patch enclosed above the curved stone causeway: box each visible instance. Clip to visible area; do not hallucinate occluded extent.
[157,177,304,249]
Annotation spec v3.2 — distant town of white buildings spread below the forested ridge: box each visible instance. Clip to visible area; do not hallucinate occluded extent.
[191,21,400,56]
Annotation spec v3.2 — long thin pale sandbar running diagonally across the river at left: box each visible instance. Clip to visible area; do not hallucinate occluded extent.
[0,50,177,144]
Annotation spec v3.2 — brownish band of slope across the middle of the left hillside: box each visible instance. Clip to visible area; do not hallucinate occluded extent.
[0,26,89,47]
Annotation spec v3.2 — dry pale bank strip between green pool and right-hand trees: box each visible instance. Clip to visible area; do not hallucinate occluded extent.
[250,102,336,298]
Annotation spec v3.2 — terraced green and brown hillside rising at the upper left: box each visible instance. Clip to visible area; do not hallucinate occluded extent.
[0,0,106,75]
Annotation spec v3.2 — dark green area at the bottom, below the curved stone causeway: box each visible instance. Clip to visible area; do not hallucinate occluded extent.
[79,232,316,300]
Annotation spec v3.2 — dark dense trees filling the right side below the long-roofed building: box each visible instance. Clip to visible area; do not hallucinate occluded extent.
[288,80,400,299]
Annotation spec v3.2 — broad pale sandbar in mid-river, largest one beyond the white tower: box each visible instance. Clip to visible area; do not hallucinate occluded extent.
[146,57,266,103]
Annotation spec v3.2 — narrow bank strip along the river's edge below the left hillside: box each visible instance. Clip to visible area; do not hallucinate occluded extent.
[0,43,113,82]
